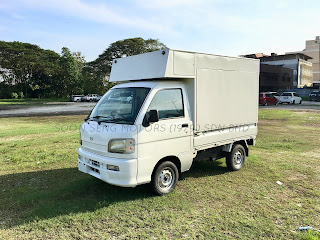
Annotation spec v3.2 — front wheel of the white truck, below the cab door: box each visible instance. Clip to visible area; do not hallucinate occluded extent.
[151,161,179,196]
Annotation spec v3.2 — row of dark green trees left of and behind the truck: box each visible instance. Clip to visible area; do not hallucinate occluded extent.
[0,38,166,98]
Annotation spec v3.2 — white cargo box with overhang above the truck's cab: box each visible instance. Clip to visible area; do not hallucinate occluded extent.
[110,49,259,132]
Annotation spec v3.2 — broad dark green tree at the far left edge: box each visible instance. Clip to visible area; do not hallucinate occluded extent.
[0,41,60,97]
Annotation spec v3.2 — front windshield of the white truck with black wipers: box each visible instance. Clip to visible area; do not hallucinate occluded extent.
[88,87,150,124]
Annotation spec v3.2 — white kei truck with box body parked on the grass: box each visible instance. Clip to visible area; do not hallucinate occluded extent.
[78,49,259,195]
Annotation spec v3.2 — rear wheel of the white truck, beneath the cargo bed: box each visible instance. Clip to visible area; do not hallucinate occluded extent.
[226,144,246,171]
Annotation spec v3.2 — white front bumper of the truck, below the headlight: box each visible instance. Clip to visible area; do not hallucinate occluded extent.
[78,147,137,187]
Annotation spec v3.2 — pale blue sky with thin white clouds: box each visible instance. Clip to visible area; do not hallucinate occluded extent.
[0,0,320,61]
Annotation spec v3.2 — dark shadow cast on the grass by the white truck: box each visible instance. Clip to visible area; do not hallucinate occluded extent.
[0,162,228,228]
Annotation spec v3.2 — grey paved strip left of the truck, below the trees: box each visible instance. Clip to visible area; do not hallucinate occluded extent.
[0,102,96,117]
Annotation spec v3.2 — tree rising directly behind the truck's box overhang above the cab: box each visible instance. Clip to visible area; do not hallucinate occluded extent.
[85,38,167,93]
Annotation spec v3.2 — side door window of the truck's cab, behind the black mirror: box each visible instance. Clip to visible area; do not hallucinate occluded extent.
[147,89,184,119]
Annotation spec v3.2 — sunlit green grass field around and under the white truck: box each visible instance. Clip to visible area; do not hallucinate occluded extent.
[0,109,320,239]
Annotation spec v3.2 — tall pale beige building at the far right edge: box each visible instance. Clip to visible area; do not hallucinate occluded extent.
[288,36,320,87]
